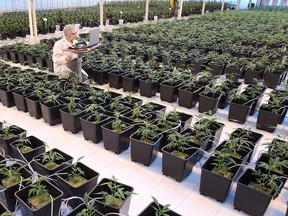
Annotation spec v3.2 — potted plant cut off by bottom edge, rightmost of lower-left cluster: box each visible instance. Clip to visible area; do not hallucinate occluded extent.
[138,196,180,216]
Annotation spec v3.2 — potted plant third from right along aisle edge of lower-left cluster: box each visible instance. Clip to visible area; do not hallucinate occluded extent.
[56,157,99,198]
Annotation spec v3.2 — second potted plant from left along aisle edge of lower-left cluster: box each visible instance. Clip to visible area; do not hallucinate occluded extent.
[10,133,46,162]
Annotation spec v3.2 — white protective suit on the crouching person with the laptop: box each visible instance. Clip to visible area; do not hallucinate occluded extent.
[52,37,88,81]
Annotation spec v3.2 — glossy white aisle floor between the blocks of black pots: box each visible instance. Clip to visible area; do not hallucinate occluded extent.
[0,79,288,216]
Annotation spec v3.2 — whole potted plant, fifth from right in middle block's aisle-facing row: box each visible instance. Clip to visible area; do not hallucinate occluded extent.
[101,113,133,154]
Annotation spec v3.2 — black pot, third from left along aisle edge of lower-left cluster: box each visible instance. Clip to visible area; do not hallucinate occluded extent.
[33,148,73,176]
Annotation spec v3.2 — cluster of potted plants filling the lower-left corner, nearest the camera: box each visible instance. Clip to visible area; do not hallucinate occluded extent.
[0,122,178,215]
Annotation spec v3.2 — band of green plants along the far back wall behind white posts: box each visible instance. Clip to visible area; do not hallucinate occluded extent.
[0,1,228,40]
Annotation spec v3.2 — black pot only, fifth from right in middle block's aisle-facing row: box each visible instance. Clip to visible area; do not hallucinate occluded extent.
[102,121,133,154]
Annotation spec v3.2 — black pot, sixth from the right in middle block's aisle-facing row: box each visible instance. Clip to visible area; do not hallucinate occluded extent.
[80,114,113,143]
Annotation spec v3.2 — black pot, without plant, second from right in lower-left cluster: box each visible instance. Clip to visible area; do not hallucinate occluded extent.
[89,178,134,215]
